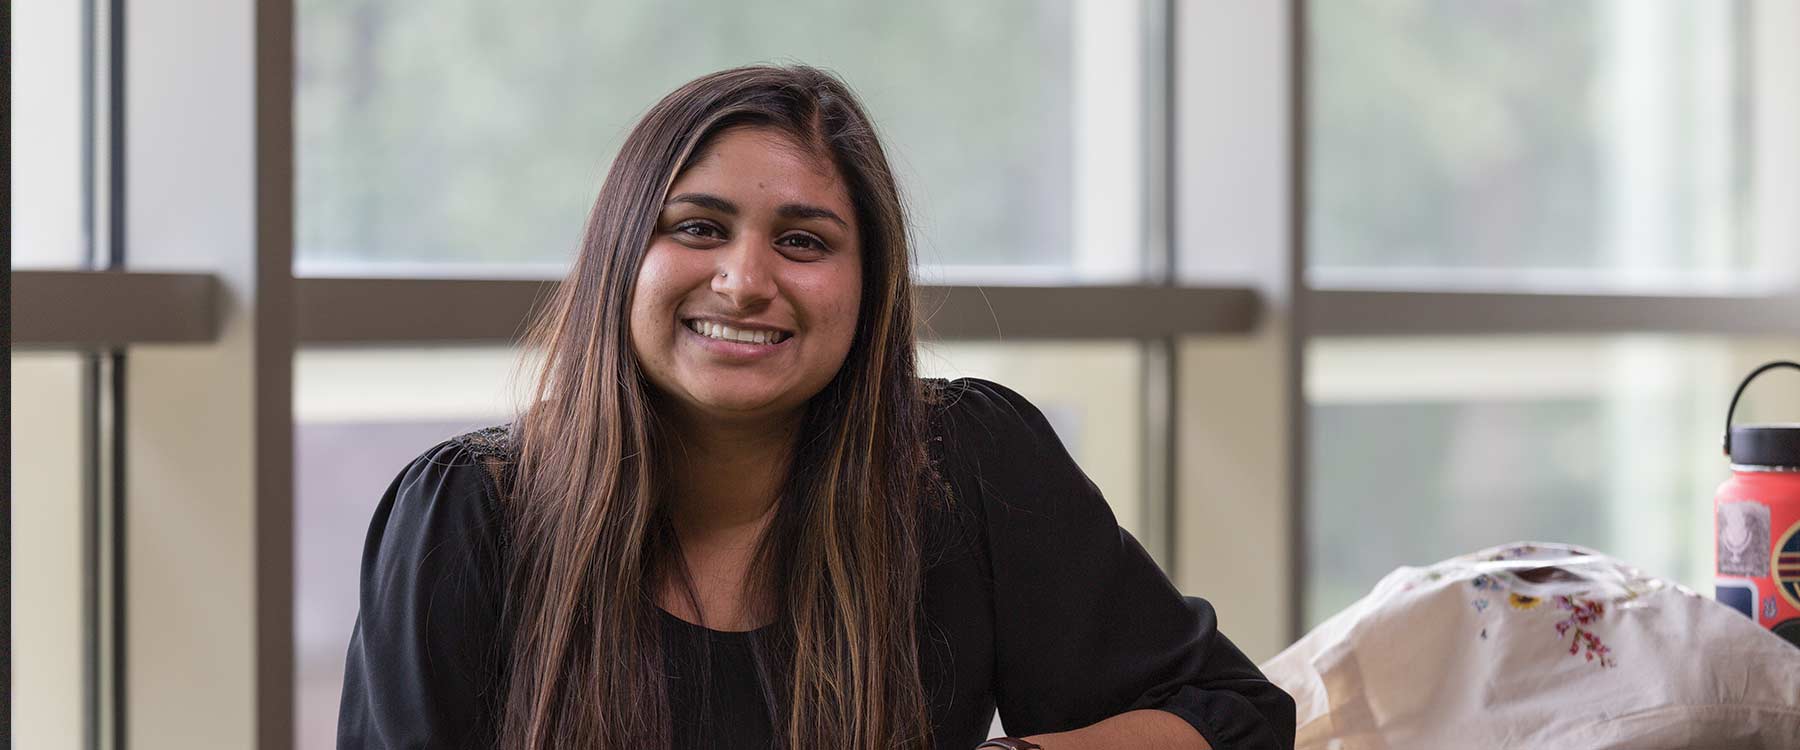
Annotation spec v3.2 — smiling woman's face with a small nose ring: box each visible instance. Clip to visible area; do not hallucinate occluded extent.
[630,128,862,421]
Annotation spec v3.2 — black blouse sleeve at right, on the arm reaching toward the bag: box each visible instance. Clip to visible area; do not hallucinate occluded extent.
[947,378,1294,750]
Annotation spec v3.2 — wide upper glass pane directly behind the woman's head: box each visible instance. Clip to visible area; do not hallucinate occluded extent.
[295,0,1143,279]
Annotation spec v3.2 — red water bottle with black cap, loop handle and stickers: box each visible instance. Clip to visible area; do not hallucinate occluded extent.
[1712,362,1800,646]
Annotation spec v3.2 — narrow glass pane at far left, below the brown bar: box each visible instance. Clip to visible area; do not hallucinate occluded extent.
[9,352,92,750]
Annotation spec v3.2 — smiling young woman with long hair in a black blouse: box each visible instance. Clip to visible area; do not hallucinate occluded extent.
[338,67,1294,750]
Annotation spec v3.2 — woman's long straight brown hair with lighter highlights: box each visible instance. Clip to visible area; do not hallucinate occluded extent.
[500,67,938,750]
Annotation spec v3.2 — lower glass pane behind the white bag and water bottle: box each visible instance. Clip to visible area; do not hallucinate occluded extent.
[1305,336,1800,626]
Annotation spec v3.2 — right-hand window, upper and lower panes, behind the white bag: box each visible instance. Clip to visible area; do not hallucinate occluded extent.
[1301,0,1800,626]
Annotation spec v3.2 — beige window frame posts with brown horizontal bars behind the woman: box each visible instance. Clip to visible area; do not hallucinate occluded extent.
[21,0,1800,748]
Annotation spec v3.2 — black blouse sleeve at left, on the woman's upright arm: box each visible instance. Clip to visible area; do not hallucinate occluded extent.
[337,435,502,750]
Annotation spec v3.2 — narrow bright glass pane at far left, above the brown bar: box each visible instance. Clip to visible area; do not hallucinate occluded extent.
[7,2,88,268]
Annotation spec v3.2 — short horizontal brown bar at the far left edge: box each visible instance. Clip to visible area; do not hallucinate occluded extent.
[11,270,221,347]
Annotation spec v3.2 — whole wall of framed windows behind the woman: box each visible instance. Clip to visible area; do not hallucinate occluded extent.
[31,0,1800,748]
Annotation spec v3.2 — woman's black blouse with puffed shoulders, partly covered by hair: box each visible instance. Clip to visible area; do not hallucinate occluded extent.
[338,378,1294,750]
